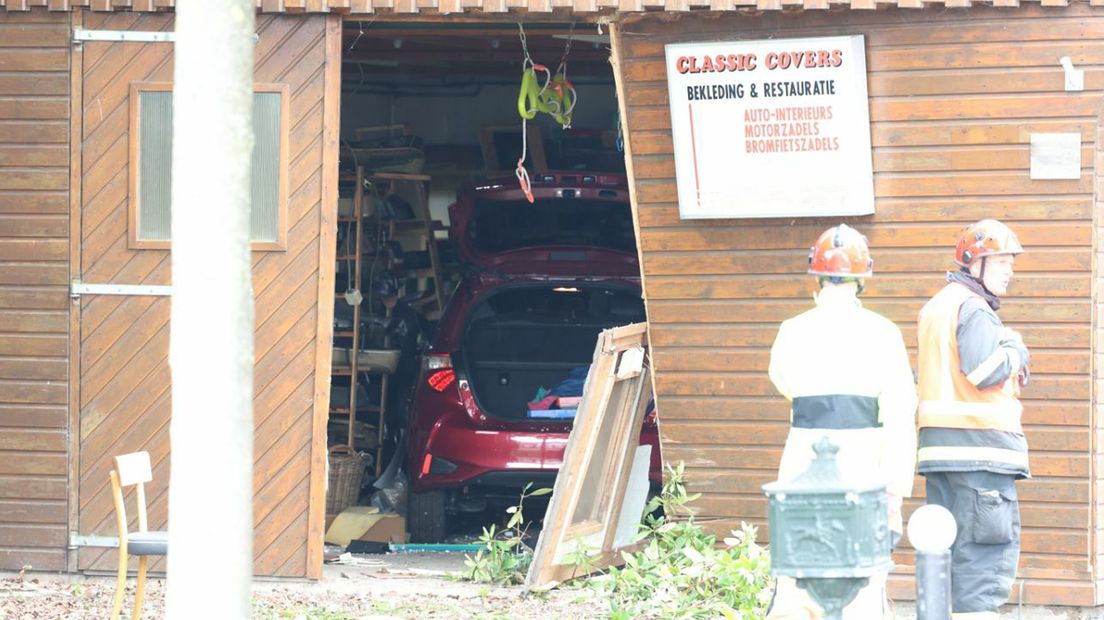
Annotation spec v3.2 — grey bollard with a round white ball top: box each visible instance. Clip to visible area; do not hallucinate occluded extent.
[909,504,958,620]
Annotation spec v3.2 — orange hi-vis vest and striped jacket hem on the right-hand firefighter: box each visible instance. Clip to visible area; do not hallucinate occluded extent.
[917,282,1029,478]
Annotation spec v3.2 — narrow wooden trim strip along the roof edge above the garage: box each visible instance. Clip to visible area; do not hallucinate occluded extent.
[0,0,1101,15]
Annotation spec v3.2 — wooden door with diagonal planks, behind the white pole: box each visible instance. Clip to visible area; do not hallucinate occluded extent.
[74,13,332,577]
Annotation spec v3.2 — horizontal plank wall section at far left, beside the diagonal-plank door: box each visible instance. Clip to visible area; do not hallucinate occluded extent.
[0,10,70,570]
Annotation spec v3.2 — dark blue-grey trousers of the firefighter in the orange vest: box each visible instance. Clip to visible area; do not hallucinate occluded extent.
[924,471,1020,613]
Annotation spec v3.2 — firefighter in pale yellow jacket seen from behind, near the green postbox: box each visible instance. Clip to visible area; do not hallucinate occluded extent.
[767,224,916,620]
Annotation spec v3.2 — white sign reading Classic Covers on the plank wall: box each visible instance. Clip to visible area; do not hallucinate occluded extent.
[666,35,874,218]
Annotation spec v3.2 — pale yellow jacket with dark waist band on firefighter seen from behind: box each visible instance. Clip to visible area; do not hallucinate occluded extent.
[769,286,916,496]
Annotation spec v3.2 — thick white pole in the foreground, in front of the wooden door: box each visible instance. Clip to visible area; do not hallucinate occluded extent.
[167,0,256,620]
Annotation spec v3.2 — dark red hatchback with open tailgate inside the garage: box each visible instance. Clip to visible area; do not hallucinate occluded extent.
[406,172,661,542]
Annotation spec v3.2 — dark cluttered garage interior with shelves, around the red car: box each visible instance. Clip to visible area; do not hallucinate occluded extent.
[327,20,643,540]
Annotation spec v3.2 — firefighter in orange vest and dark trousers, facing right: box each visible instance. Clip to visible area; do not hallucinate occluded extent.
[917,220,1030,620]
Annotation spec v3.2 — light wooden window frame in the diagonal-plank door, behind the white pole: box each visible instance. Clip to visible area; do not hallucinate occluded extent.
[127,82,291,252]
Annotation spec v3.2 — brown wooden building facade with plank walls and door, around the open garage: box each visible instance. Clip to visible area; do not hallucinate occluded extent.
[0,0,1104,607]
